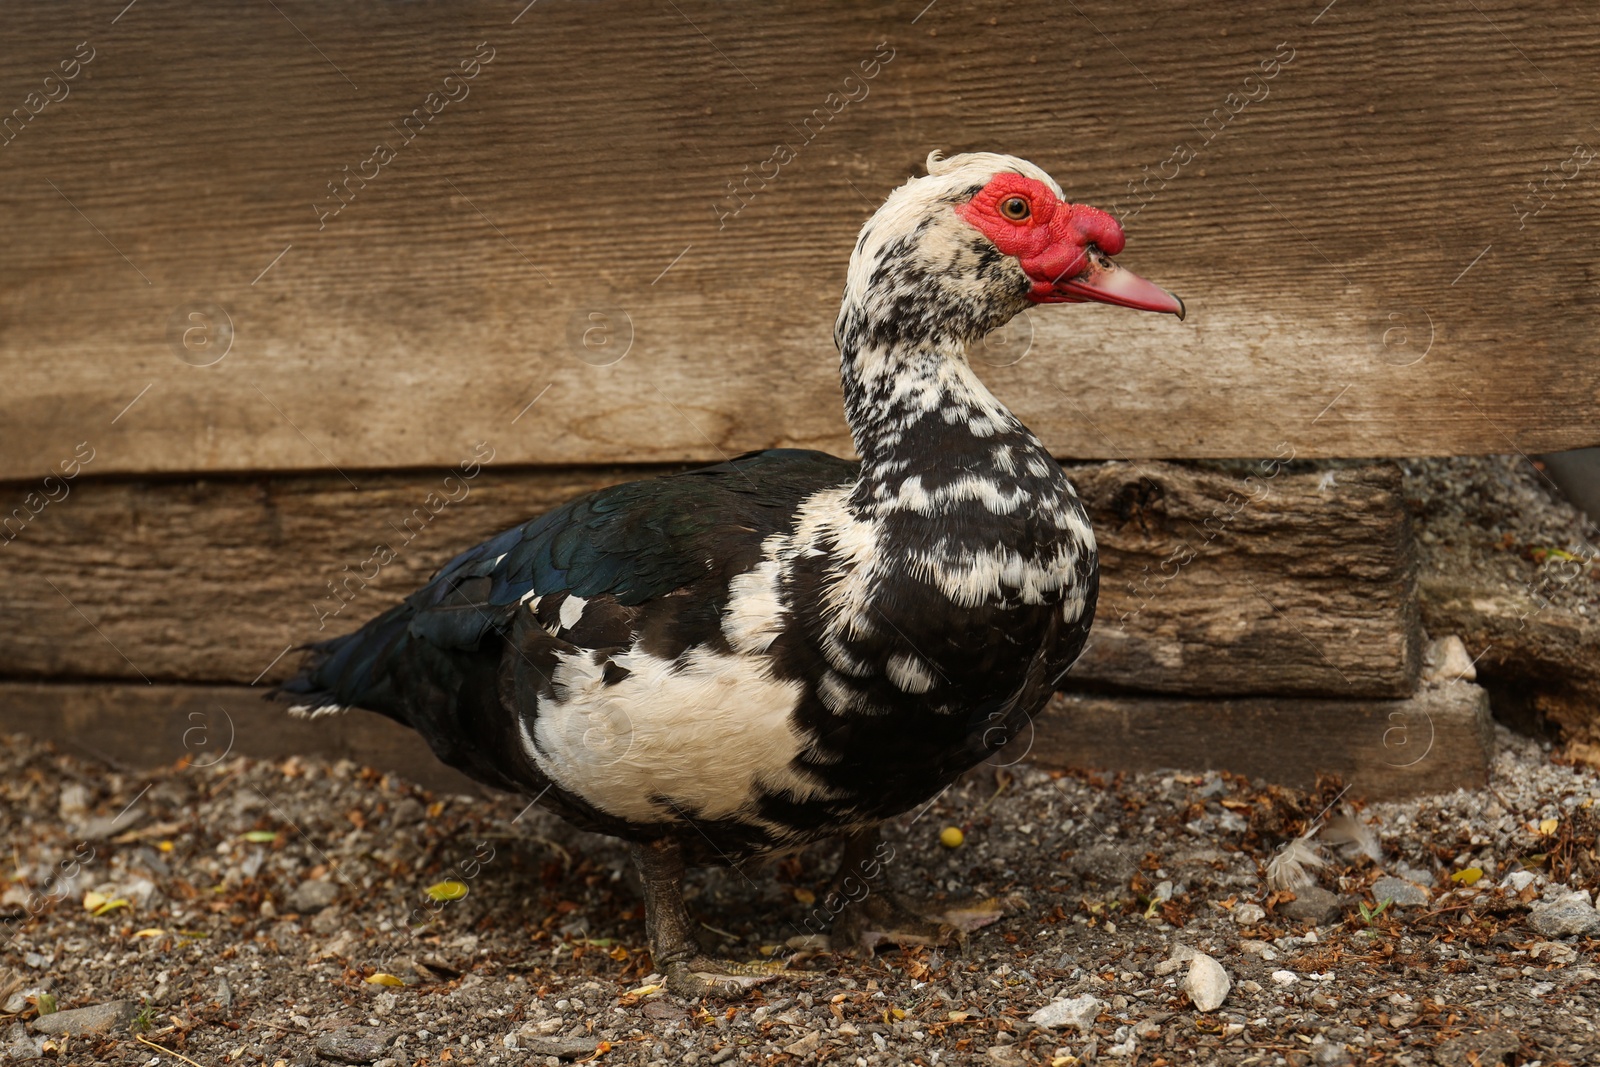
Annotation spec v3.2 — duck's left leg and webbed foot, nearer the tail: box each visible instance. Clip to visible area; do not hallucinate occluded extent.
[634,840,782,997]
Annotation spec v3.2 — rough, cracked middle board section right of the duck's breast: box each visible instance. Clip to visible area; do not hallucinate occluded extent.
[1069,462,1421,697]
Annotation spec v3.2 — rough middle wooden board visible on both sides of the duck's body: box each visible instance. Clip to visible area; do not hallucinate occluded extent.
[0,462,1416,696]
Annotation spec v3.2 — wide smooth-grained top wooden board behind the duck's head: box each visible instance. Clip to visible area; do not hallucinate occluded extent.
[0,0,1600,478]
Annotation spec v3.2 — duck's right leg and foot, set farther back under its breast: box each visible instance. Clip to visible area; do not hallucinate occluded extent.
[826,827,1005,955]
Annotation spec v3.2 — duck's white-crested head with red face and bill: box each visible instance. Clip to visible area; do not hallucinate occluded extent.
[840,152,1184,347]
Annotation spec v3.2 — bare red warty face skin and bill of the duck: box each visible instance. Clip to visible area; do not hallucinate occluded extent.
[955,171,1184,318]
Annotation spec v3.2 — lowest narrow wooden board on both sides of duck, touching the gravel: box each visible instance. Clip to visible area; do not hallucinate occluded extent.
[0,681,1493,800]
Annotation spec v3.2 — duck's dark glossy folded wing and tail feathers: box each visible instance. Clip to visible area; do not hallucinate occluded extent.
[274,450,859,785]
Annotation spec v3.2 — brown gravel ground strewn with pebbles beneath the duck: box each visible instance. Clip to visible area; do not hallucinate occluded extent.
[0,729,1600,1067]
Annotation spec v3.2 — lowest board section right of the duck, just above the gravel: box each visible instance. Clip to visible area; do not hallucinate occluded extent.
[1030,681,1494,800]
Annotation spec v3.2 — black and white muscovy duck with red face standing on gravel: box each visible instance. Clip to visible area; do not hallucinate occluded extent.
[278,152,1184,995]
